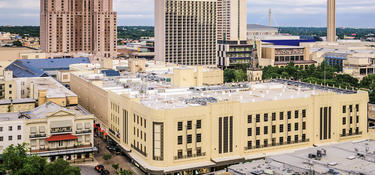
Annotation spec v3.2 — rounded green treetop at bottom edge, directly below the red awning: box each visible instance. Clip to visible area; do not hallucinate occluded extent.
[44,159,81,175]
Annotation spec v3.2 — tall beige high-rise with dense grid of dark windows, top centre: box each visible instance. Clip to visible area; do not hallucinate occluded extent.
[155,0,217,65]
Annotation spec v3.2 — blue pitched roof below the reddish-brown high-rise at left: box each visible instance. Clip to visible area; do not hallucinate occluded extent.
[6,57,90,77]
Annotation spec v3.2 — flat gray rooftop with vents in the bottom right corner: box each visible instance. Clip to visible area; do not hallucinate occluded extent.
[229,140,375,175]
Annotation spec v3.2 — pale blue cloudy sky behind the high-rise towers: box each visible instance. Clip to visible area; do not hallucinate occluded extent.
[0,0,375,28]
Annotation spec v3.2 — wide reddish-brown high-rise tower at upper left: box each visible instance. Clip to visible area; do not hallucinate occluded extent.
[40,0,117,58]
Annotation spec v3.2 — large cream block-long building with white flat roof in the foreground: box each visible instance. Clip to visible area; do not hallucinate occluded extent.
[72,67,369,174]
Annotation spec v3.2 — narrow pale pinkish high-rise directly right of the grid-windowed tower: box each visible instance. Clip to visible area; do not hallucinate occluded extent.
[217,0,247,41]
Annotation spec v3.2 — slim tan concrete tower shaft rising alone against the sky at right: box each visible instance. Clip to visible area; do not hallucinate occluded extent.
[327,0,336,42]
